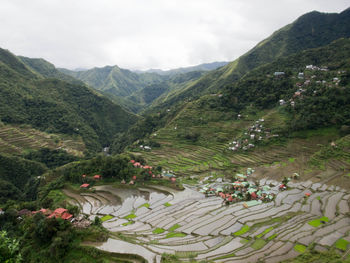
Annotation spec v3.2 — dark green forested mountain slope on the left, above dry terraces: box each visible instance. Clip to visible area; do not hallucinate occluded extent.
[0,46,138,151]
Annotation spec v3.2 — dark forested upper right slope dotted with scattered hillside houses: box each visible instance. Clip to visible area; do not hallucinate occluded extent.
[217,38,350,129]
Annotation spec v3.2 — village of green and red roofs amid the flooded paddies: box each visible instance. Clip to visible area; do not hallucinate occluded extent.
[200,168,275,207]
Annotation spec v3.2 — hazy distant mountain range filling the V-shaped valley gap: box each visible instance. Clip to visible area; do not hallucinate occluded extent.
[59,62,227,112]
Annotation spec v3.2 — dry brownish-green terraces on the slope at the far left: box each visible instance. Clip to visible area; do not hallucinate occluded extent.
[0,124,85,156]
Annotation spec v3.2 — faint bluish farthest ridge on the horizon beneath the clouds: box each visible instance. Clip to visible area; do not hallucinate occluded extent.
[134,62,229,75]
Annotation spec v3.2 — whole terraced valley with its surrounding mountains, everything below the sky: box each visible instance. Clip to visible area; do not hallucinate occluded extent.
[0,5,350,263]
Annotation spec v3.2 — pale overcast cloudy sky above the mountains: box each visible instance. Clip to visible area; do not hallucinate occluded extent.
[0,0,350,69]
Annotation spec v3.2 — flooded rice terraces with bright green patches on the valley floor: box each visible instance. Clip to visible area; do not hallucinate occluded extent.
[65,182,350,262]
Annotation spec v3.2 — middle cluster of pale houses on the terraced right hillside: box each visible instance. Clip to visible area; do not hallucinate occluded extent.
[228,118,278,151]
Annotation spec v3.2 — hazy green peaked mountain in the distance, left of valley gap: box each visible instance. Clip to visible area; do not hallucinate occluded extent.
[60,66,164,97]
